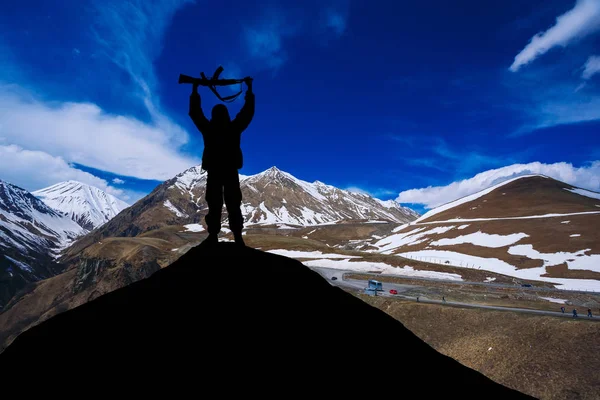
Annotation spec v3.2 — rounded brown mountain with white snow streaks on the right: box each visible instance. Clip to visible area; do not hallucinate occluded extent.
[370,175,600,291]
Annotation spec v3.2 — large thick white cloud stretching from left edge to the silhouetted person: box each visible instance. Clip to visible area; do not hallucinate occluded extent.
[0,85,199,180]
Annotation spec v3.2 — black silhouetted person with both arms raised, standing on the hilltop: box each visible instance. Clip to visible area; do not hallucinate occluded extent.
[189,78,254,245]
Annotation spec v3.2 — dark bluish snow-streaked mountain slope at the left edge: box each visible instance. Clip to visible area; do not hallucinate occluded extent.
[0,181,86,307]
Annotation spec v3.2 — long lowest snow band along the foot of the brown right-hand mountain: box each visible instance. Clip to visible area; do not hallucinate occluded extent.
[398,250,600,292]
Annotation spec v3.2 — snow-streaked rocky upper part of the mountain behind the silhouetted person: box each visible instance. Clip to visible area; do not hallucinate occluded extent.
[171,167,418,226]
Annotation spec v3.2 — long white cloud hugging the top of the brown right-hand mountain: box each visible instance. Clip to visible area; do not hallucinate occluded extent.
[396,161,600,208]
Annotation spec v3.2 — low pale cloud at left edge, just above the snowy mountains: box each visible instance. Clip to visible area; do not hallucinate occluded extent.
[0,145,127,199]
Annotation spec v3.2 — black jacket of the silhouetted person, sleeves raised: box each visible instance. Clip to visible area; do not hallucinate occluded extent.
[189,91,254,171]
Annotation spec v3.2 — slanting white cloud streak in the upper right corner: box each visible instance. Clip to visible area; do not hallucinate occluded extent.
[510,0,600,72]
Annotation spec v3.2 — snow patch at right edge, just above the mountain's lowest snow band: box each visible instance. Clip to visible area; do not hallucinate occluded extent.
[508,244,600,274]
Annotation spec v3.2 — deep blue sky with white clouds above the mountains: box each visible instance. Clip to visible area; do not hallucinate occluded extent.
[0,0,600,210]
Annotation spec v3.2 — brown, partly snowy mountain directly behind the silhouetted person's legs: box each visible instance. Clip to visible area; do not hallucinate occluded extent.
[69,166,419,254]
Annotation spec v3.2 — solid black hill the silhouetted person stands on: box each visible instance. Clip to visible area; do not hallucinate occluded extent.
[0,243,528,399]
